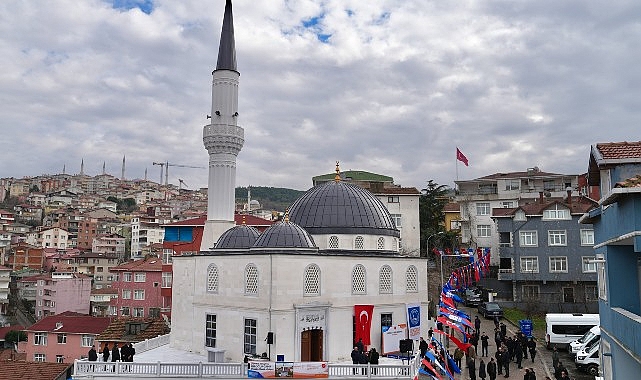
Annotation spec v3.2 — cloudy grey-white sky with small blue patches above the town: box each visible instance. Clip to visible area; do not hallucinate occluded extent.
[0,0,641,190]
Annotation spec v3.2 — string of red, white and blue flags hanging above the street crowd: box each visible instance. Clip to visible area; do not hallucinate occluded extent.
[415,248,490,380]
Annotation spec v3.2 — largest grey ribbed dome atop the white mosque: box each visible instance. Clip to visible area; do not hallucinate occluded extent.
[289,180,400,237]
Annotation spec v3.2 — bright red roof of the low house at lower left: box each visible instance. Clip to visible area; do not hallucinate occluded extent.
[26,311,111,335]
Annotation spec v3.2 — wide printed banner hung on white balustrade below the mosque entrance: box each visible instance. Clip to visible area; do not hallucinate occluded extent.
[247,361,329,379]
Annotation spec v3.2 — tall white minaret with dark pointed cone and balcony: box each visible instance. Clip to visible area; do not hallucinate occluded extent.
[200,0,245,251]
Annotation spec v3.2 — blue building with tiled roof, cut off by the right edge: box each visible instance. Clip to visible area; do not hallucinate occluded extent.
[580,141,641,379]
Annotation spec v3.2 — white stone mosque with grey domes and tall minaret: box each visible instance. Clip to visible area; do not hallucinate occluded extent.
[170,0,428,362]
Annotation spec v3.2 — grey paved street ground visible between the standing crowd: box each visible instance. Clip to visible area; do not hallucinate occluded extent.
[442,307,594,380]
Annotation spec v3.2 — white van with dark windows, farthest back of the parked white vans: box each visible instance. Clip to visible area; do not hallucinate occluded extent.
[545,313,600,349]
